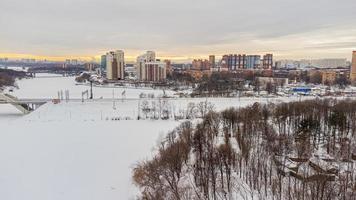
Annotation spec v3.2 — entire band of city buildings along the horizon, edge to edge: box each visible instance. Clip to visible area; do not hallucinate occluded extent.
[0,50,356,85]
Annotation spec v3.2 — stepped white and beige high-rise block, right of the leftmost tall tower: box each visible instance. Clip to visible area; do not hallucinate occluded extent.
[136,51,167,82]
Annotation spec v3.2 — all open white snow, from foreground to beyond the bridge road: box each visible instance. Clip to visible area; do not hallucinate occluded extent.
[0,77,354,200]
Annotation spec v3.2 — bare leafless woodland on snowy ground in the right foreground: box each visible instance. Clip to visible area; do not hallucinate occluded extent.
[133,99,356,200]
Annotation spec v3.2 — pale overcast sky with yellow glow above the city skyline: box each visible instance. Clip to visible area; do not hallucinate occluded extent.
[0,0,356,61]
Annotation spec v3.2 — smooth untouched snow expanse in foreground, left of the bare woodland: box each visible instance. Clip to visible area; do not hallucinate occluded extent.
[0,120,178,200]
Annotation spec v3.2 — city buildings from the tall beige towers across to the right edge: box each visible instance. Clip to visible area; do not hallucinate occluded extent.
[96,50,356,84]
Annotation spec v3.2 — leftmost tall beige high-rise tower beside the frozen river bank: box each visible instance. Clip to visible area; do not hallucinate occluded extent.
[106,50,125,80]
